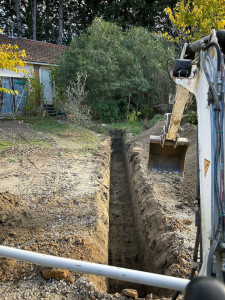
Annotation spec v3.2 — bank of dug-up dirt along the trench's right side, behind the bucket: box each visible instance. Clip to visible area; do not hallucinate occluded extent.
[126,122,196,295]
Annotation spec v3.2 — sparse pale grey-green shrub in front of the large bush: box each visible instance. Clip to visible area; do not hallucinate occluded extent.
[63,72,91,126]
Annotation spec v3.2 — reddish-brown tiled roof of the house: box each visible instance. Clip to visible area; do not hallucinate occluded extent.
[0,34,66,64]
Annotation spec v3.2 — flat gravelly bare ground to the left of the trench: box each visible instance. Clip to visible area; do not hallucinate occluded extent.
[0,120,110,299]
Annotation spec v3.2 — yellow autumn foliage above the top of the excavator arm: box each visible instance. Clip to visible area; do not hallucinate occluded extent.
[162,0,225,44]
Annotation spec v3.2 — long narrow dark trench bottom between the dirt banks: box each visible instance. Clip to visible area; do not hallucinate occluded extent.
[108,130,146,296]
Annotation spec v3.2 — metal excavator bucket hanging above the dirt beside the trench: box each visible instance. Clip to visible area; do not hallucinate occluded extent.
[148,135,190,175]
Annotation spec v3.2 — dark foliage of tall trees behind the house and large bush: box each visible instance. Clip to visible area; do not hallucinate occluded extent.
[0,0,176,44]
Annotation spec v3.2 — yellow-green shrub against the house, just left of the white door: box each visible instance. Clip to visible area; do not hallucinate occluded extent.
[24,71,44,116]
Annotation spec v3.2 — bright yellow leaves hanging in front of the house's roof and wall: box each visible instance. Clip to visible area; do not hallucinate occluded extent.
[0,30,26,94]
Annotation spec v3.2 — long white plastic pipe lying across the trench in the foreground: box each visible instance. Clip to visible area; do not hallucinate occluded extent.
[0,246,190,291]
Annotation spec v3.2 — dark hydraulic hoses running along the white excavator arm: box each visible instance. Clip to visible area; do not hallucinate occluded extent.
[202,47,224,276]
